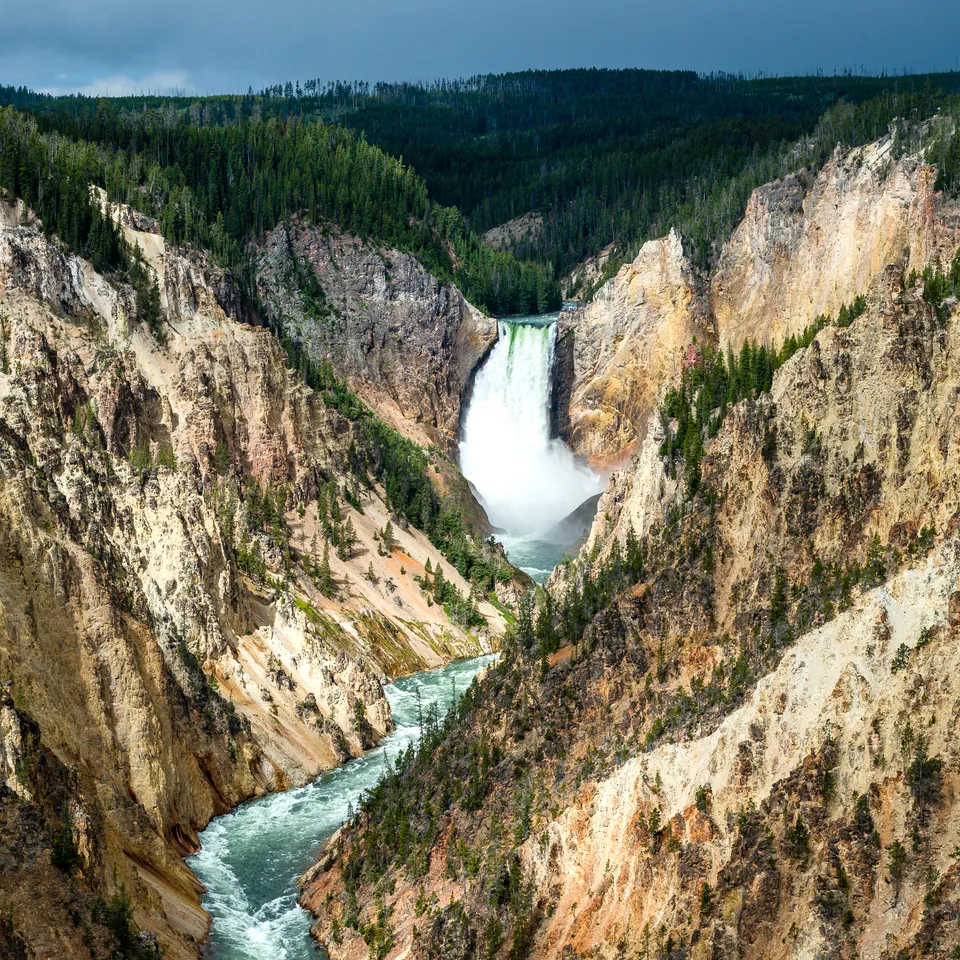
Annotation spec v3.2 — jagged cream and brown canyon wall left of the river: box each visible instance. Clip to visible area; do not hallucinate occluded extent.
[0,199,503,958]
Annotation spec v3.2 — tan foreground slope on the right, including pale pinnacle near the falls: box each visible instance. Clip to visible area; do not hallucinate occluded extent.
[303,156,960,960]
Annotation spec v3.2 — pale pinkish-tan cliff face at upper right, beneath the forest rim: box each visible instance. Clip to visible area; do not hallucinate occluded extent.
[711,131,960,348]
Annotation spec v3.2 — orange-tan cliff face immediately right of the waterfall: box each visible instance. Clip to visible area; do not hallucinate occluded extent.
[557,232,713,466]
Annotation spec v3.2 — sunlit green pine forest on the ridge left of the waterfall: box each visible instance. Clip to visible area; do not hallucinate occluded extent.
[0,98,560,313]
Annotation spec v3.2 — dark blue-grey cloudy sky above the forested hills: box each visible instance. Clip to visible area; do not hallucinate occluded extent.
[0,0,960,94]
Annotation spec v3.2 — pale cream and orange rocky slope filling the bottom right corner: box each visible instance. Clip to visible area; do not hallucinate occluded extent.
[521,541,960,960]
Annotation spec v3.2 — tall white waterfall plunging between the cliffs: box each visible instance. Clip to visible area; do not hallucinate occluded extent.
[460,317,603,536]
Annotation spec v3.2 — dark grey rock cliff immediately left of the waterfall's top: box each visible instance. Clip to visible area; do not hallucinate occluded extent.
[251,221,497,453]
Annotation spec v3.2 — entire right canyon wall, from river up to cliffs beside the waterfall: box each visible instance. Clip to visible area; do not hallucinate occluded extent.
[302,131,960,960]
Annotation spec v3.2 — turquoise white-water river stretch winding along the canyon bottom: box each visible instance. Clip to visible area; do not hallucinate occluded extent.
[188,655,496,960]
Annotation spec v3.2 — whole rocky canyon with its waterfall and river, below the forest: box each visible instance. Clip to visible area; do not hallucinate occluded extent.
[0,94,960,960]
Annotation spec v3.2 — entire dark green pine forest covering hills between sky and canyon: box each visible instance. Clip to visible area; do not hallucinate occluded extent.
[7,70,960,296]
